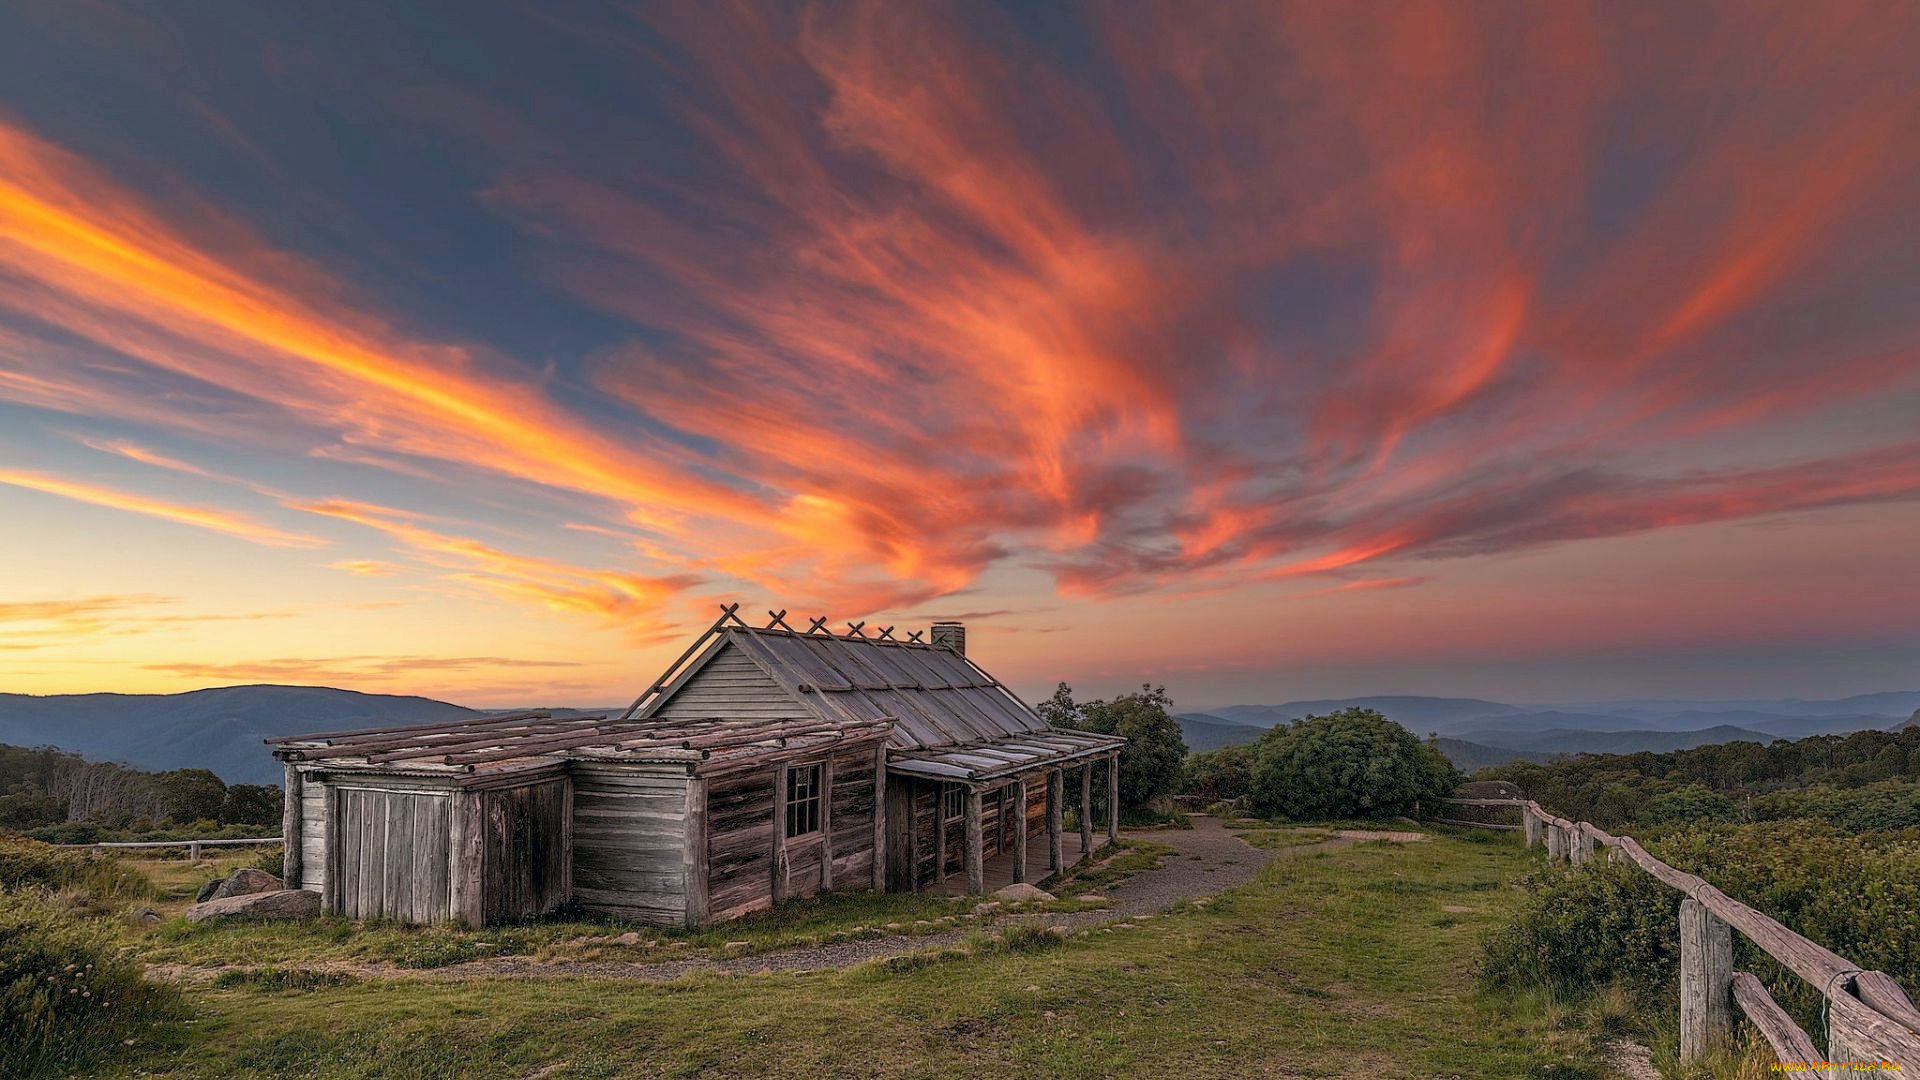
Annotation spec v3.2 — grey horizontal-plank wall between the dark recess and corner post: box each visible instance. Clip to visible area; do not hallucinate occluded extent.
[572,763,705,926]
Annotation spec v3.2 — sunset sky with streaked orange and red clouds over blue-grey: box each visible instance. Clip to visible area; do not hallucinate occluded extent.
[0,0,1920,707]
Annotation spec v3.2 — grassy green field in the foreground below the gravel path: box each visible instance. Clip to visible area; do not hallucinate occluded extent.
[97,834,1603,1080]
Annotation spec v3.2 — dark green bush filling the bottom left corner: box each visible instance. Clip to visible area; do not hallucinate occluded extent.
[0,894,180,1076]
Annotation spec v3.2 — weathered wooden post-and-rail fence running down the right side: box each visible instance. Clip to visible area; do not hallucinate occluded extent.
[1444,799,1920,1076]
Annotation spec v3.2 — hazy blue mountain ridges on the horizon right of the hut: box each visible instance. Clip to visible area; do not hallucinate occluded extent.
[1177,690,1920,771]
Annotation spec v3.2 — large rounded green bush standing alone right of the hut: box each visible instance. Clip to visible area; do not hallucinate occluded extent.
[1252,709,1459,821]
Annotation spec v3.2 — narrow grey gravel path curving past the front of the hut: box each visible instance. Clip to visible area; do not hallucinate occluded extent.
[165,817,1390,982]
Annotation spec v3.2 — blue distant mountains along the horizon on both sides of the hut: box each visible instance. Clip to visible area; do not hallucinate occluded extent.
[0,686,1920,784]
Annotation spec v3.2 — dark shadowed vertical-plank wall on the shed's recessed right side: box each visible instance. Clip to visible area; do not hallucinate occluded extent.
[480,778,572,922]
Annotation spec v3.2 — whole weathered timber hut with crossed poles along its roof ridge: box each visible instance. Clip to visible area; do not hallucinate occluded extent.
[273,605,1125,926]
